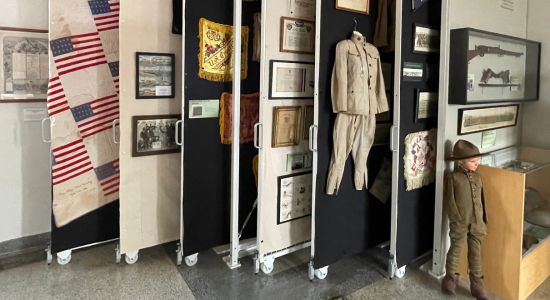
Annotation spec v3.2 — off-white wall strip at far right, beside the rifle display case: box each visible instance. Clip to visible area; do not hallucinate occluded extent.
[522,0,550,148]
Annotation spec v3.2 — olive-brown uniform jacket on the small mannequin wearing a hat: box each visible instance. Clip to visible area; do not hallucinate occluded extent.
[443,167,487,224]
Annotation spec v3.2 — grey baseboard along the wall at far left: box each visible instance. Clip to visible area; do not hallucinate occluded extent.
[0,232,51,270]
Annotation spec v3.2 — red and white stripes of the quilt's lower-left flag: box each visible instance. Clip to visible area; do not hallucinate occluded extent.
[52,139,94,185]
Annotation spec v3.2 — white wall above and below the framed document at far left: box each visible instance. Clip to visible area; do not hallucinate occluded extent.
[0,0,51,242]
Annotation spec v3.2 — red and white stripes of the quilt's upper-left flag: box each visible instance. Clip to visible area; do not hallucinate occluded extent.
[53,32,107,76]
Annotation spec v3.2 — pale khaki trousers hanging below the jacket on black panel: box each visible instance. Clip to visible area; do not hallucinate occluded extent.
[326,113,376,195]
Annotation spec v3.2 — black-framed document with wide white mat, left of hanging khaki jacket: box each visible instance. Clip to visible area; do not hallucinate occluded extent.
[269,60,315,99]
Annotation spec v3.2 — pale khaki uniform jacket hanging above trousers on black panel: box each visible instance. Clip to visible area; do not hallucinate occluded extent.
[331,36,389,115]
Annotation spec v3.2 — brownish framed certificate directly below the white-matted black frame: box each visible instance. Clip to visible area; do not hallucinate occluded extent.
[271,106,302,148]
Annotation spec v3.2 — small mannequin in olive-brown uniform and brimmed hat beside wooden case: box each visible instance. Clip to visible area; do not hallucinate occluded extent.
[441,140,488,299]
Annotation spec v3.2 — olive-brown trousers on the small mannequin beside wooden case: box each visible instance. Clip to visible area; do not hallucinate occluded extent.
[445,222,487,278]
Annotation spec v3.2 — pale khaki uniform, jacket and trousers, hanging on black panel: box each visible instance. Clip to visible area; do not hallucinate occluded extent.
[326,32,388,195]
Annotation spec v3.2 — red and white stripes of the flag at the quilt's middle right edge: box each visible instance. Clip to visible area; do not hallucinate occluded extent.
[77,95,119,138]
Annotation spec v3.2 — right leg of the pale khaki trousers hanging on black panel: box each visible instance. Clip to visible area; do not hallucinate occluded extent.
[351,115,376,190]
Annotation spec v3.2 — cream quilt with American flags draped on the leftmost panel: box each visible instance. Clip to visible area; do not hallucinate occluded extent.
[47,0,119,227]
